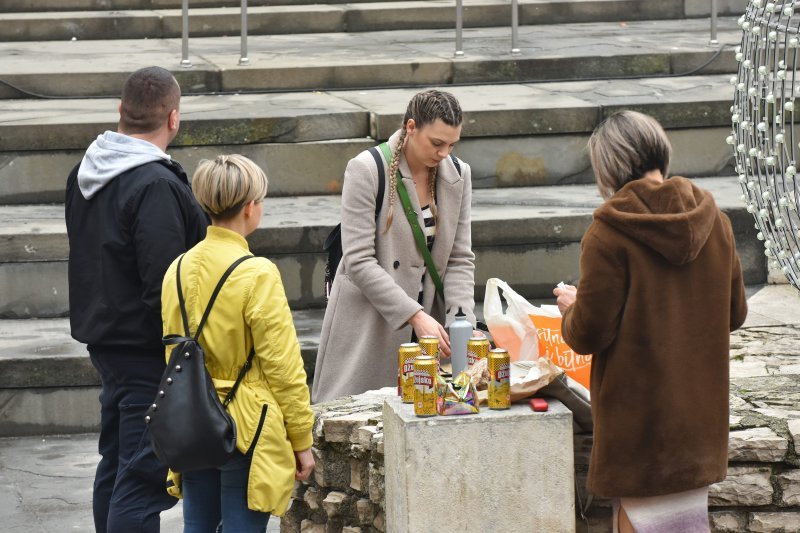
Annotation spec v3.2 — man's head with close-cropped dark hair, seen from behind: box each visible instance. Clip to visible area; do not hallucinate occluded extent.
[119,67,181,133]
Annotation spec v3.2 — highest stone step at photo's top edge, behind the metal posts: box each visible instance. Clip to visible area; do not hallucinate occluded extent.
[0,0,685,42]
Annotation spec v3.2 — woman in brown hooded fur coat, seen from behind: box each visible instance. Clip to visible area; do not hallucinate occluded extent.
[554,111,747,533]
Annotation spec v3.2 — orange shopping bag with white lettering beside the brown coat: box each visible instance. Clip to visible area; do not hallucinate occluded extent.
[528,305,592,389]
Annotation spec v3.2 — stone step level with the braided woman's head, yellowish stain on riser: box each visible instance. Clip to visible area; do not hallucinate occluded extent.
[0,74,732,204]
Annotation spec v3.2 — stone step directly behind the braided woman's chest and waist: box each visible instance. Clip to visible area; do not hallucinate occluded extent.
[0,178,767,318]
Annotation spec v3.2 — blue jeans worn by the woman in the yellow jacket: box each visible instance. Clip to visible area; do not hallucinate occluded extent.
[181,451,270,533]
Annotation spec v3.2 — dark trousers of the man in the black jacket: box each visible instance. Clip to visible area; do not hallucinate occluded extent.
[89,349,177,533]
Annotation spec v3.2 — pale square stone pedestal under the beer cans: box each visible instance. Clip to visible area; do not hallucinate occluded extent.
[383,397,575,533]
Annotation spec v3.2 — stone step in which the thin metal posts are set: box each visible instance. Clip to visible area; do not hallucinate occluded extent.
[0,17,741,98]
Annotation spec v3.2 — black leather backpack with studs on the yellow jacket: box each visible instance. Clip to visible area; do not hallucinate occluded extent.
[145,255,255,472]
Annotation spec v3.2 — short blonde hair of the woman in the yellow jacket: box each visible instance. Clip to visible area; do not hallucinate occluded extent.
[192,154,268,220]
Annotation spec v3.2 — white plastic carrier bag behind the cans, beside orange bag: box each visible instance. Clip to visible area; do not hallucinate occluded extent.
[483,278,541,361]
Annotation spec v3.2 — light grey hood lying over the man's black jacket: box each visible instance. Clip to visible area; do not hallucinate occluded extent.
[78,131,170,200]
